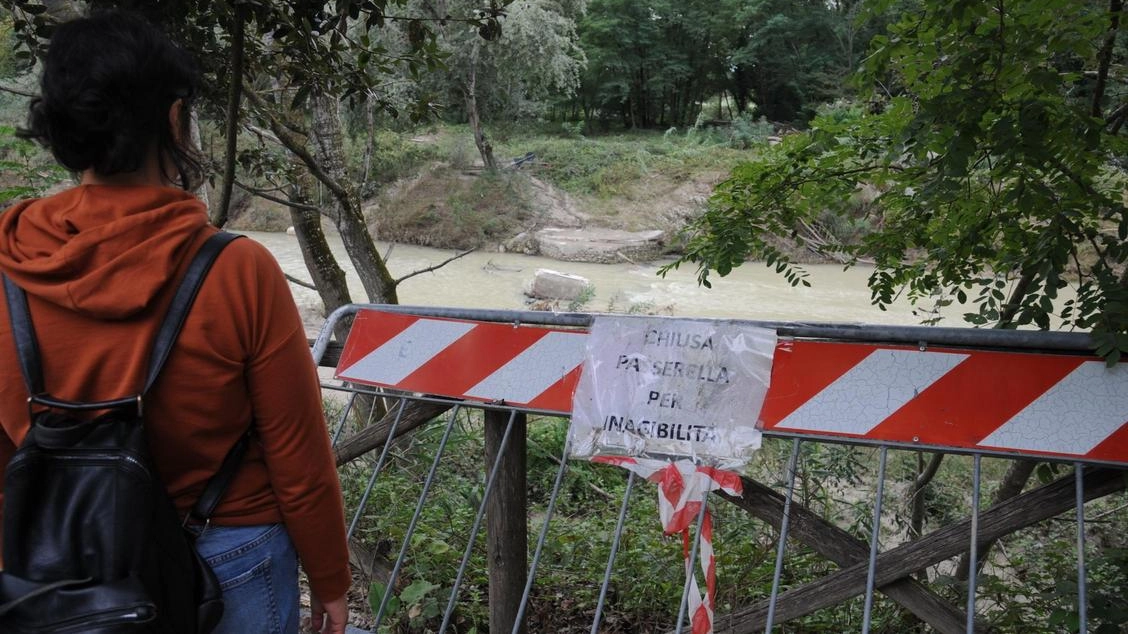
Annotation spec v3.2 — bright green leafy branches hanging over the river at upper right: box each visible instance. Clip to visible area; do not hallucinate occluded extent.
[662,0,1128,363]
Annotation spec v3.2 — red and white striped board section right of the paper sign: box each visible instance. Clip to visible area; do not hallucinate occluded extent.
[760,341,1128,463]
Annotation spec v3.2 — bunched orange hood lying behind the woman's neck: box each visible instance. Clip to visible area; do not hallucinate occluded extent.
[0,185,208,319]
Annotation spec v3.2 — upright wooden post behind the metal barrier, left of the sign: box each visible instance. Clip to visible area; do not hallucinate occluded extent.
[485,411,529,634]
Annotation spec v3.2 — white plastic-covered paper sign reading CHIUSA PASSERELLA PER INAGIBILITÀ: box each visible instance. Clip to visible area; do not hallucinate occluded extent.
[569,317,776,469]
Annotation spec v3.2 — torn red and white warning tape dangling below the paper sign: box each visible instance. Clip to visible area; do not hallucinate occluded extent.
[592,456,743,634]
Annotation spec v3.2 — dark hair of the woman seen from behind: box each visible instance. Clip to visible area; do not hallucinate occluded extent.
[20,10,203,190]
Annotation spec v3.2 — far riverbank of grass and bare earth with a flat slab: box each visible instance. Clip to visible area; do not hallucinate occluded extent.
[231,125,839,263]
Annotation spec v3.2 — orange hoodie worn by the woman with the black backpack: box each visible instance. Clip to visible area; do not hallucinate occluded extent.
[0,185,350,601]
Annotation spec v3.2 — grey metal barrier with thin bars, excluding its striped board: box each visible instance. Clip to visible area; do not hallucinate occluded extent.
[314,306,1128,634]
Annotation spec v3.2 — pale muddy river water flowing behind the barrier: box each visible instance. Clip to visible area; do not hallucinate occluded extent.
[247,231,938,326]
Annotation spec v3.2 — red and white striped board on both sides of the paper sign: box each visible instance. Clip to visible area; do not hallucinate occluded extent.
[337,310,1128,465]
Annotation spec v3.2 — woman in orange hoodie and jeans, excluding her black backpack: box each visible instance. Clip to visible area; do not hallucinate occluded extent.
[0,11,351,634]
